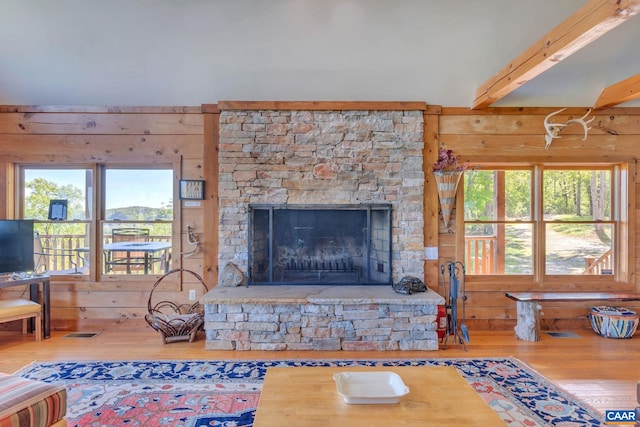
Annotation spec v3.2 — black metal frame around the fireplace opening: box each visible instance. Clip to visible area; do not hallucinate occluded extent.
[247,203,393,286]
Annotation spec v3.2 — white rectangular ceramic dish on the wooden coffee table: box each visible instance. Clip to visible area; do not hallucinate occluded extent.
[333,371,409,405]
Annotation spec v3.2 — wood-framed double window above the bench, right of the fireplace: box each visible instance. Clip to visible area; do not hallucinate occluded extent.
[464,165,619,278]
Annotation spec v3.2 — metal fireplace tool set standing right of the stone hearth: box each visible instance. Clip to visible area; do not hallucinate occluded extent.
[440,261,470,351]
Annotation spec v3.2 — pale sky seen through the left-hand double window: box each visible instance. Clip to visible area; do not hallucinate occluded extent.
[25,169,173,209]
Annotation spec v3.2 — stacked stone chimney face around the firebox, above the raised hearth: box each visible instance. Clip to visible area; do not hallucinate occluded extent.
[218,110,424,282]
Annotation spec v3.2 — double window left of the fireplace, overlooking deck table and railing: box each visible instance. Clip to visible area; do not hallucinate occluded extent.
[19,165,174,278]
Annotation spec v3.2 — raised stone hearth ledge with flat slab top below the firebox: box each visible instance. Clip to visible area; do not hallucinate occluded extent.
[200,285,444,351]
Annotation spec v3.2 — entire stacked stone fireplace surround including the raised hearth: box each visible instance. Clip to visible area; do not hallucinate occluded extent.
[201,106,444,350]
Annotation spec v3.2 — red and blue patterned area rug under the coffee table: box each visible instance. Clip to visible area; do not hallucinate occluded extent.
[18,358,605,427]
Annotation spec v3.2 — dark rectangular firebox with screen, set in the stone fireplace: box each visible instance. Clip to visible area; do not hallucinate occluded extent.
[248,204,392,285]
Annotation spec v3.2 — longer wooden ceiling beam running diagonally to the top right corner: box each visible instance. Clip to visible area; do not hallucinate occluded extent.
[471,0,640,109]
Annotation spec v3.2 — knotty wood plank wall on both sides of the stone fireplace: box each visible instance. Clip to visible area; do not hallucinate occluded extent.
[0,103,640,331]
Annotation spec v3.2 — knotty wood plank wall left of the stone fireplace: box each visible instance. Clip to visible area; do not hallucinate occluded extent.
[0,106,208,331]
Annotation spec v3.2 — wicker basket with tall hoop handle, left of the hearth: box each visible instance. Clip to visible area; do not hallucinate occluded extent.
[144,268,209,344]
